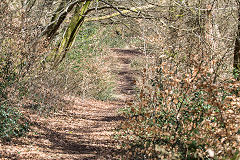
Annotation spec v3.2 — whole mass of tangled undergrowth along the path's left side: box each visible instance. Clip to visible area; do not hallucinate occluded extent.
[0,5,127,140]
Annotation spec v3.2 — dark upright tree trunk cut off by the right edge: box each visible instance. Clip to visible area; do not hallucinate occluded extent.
[233,1,240,74]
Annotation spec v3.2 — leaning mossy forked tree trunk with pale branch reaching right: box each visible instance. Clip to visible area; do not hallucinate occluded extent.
[44,0,154,67]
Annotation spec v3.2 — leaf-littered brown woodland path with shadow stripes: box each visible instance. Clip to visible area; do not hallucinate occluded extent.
[0,49,141,160]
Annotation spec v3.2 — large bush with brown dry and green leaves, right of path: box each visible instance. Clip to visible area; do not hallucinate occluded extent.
[119,58,240,159]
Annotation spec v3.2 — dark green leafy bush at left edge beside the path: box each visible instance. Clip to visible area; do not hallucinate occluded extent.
[0,58,30,141]
